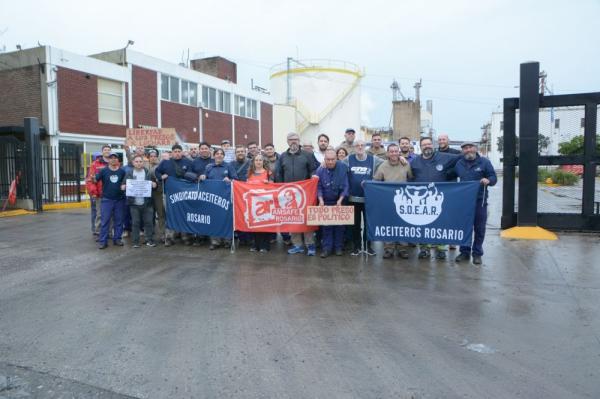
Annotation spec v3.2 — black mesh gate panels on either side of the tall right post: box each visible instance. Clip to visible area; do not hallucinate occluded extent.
[502,88,600,230]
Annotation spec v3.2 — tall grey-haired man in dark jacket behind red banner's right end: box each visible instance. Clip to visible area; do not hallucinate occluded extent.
[275,132,316,256]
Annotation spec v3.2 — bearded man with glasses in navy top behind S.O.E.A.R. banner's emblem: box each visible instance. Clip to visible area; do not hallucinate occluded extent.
[410,137,460,260]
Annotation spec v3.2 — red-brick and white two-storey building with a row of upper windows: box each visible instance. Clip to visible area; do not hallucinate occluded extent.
[0,46,273,159]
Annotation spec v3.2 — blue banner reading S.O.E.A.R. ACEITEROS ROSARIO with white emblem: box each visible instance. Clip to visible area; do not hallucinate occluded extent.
[365,181,479,245]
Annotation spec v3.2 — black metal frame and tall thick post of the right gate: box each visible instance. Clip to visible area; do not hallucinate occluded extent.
[501,63,600,231]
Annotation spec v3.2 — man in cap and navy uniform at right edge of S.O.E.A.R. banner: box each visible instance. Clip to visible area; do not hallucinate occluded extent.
[454,142,498,265]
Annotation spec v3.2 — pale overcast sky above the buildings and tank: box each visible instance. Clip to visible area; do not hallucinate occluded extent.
[0,0,600,139]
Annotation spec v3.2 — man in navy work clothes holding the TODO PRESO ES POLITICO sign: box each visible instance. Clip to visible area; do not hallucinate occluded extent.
[317,150,348,258]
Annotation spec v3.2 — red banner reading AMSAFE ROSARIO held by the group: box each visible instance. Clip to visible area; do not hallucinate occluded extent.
[233,179,318,233]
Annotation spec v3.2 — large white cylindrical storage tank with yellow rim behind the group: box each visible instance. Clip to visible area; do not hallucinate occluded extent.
[271,58,363,151]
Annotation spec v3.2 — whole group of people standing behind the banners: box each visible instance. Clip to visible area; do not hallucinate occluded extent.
[87,129,497,264]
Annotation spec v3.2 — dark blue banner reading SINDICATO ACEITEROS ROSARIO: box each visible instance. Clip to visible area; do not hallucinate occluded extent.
[165,177,233,238]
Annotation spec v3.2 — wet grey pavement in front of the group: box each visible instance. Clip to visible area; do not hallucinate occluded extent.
[0,210,600,399]
